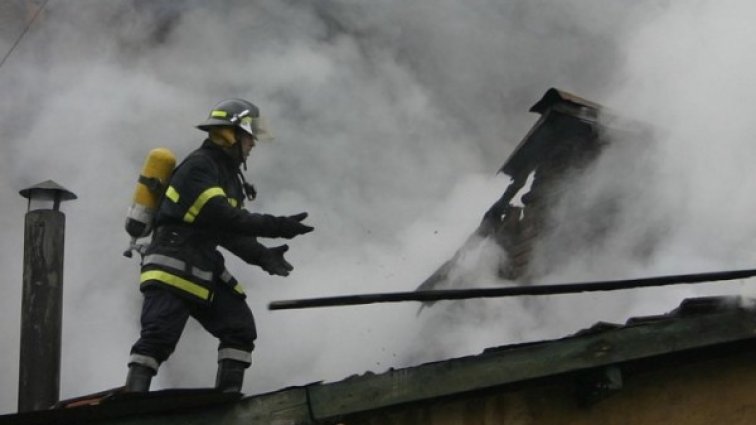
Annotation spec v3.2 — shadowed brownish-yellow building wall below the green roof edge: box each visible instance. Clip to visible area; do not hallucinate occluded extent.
[342,344,756,425]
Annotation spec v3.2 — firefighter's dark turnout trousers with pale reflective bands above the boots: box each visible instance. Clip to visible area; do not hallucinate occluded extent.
[129,285,257,371]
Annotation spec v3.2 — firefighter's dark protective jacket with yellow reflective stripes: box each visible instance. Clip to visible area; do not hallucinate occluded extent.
[140,140,277,303]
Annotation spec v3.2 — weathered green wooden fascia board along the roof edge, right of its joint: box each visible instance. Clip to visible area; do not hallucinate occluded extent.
[307,296,756,420]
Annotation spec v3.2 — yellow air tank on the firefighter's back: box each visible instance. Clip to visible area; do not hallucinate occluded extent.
[126,148,176,242]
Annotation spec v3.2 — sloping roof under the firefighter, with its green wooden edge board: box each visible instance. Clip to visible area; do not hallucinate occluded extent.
[0,297,756,425]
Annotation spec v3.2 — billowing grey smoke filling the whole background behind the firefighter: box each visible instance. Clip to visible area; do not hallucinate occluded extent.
[0,0,756,412]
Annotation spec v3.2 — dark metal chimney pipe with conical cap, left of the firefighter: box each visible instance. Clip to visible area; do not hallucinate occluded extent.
[18,180,76,412]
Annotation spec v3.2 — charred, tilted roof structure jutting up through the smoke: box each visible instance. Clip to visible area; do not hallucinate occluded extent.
[417,88,651,291]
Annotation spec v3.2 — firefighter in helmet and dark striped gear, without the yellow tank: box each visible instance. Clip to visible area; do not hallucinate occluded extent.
[125,99,313,392]
